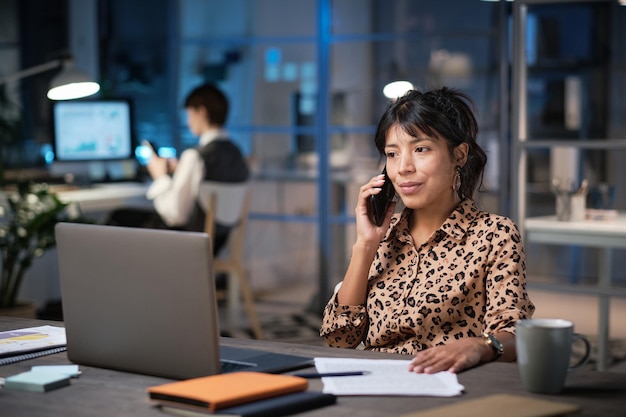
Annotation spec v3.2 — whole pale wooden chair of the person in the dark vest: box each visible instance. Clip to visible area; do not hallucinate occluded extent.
[200,182,263,339]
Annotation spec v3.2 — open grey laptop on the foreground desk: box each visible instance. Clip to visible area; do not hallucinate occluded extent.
[55,223,313,379]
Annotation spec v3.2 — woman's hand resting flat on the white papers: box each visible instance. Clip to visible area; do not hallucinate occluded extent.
[409,337,493,374]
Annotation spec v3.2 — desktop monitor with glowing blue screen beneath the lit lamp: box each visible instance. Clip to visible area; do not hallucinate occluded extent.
[53,99,134,162]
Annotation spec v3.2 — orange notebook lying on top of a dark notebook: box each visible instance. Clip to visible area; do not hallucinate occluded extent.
[148,372,308,411]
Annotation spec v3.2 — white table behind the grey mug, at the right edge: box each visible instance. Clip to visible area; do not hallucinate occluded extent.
[524,213,626,371]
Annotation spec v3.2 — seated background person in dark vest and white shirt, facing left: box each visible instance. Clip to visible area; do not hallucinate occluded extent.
[107,84,250,254]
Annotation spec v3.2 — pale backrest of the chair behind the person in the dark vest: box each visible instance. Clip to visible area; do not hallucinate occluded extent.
[199,182,250,255]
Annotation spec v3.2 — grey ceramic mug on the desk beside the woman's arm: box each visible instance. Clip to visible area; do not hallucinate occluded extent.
[515,319,591,394]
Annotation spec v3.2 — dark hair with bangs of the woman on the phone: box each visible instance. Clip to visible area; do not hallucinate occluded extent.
[374,87,487,199]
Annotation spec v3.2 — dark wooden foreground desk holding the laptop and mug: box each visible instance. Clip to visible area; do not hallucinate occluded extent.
[0,317,626,417]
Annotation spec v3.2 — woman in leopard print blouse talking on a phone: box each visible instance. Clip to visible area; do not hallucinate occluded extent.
[320,87,534,373]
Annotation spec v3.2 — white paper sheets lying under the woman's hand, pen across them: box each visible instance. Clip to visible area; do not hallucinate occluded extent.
[315,358,464,397]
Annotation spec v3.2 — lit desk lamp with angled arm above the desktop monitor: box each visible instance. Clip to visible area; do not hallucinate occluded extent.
[0,56,100,100]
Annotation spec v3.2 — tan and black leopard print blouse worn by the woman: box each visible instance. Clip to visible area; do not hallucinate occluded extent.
[320,200,535,354]
